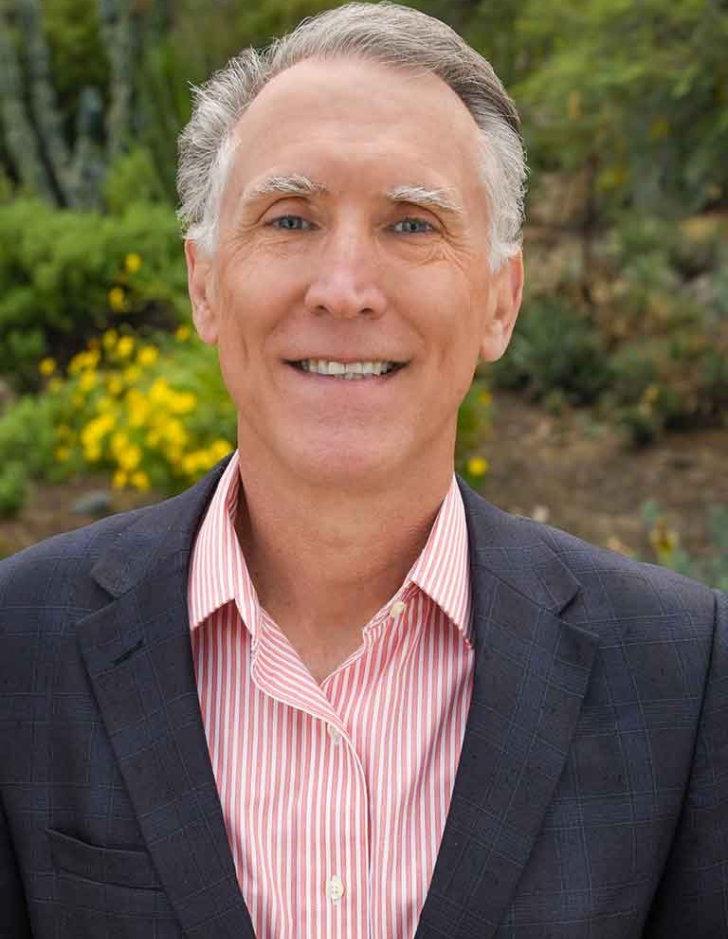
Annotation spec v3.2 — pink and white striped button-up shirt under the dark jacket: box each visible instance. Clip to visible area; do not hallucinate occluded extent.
[188,453,473,939]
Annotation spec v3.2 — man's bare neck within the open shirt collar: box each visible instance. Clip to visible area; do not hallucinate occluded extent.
[236,446,453,671]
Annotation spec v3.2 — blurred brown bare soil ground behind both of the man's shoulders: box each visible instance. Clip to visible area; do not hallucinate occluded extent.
[0,392,728,558]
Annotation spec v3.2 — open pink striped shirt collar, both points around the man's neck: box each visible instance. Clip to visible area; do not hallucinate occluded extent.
[188,450,471,642]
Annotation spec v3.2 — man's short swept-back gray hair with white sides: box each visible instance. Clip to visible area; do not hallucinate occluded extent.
[177,2,527,270]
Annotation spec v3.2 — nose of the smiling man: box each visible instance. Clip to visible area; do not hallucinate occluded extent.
[305,226,386,319]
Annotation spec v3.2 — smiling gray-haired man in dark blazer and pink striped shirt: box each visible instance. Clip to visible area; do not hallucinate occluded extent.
[0,4,728,939]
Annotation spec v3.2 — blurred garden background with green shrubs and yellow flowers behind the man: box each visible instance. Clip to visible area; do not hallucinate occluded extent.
[0,0,728,588]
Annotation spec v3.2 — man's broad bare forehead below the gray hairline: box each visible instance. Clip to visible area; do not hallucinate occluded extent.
[222,58,481,210]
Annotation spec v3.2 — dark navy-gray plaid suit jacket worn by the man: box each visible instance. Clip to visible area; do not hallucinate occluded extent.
[0,458,728,939]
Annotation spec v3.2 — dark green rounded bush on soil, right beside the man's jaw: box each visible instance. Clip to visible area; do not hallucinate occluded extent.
[492,297,609,404]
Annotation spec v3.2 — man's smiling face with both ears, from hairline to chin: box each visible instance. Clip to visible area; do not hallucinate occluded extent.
[187,59,522,485]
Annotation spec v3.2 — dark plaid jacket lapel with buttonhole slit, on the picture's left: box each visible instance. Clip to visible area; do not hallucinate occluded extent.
[78,466,254,939]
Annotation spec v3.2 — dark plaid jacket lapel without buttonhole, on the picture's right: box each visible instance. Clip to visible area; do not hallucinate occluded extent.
[416,483,596,939]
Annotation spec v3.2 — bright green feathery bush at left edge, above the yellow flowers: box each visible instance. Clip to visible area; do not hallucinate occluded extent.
[0,200,189,390]
